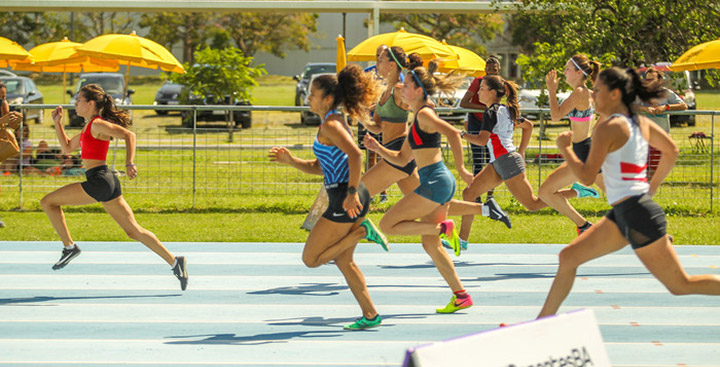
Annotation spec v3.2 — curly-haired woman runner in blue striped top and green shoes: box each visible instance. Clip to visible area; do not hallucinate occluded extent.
[270,65,387,330]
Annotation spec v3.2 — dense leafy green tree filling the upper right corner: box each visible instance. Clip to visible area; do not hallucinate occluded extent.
[510,0,720,84]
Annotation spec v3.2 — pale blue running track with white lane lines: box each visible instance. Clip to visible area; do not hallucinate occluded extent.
[0,241,720,367]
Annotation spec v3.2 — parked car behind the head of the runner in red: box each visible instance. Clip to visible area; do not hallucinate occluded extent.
[67,73,135,127]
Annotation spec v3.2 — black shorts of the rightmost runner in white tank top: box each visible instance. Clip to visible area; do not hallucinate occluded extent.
[605,194,667,249]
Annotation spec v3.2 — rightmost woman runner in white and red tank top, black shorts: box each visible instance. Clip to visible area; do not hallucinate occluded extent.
[538,68,720,318]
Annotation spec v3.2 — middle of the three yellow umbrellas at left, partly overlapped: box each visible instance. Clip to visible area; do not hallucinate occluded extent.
[12,37,120,104]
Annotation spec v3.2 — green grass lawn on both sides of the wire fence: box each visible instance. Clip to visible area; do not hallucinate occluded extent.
[0,76,720,244]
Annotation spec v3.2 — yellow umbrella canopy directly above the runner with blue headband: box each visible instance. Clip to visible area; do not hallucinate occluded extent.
[347,29,456,61]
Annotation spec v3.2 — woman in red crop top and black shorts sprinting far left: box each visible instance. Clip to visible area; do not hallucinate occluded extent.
[40,84,188,290]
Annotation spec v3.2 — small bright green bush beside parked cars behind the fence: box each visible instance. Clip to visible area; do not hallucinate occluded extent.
[169,48,267,101]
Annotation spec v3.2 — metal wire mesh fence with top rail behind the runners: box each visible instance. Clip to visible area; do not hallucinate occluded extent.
[0,105,720,213]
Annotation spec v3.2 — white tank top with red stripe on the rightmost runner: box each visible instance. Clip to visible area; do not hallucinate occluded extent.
[602,114,650,204]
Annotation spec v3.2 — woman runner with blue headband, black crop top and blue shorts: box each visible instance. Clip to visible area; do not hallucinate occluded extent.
[365,62,473,313]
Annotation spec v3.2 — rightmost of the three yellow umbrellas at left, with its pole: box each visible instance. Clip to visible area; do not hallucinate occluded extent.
[77,32,185,95]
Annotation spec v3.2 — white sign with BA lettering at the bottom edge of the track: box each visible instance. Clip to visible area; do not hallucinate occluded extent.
[403,310,611,367]
